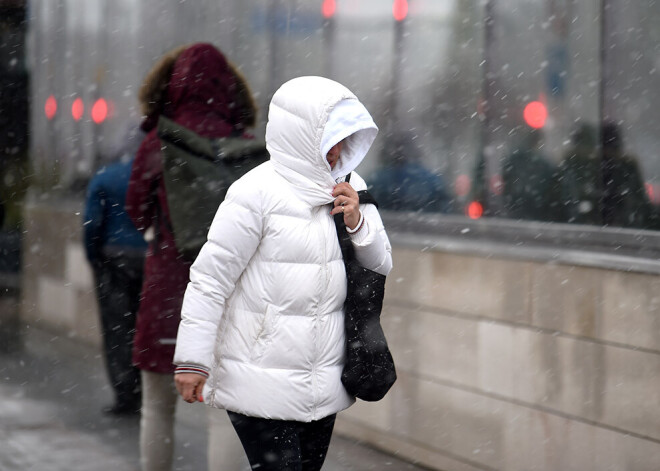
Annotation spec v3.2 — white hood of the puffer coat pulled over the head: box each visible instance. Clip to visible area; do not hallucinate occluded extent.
[266,77,378,206]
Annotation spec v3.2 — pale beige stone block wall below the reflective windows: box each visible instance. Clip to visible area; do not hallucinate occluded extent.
[22,203,660,471]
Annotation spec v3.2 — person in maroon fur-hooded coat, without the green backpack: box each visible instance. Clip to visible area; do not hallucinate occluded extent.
[126,43,256,471]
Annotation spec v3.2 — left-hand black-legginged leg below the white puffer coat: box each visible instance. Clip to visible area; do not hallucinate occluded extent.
[227,411,303,471]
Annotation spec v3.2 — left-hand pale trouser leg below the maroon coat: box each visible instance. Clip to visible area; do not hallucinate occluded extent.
[140,371,178,471]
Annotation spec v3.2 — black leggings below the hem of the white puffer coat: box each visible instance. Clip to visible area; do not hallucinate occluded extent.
[227,411,337,471]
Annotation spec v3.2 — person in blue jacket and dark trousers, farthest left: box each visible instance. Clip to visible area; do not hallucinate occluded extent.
[83,143,147,415]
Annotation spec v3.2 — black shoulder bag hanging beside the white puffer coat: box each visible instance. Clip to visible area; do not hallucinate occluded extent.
[334,175,396,401]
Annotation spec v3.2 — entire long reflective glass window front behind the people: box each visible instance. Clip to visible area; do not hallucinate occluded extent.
[31,0,660,234]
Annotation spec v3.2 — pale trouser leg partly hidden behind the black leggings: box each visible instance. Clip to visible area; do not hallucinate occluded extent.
[207,407,250,471]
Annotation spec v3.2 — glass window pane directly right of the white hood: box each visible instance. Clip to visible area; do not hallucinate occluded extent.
[366,0,482,213]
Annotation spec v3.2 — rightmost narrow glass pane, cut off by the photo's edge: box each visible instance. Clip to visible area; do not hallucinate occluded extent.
[599,0,660,230]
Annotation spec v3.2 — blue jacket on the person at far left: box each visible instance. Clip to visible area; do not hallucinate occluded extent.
[83,159,147,263]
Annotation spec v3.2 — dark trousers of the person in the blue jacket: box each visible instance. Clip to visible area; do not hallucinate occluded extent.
[94,255,144,409]
